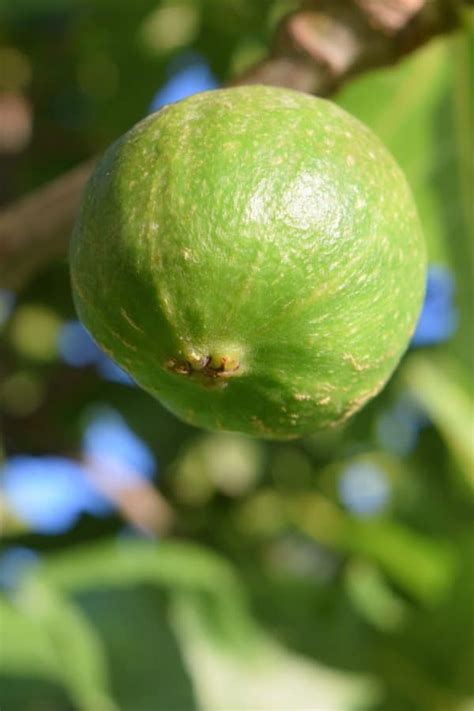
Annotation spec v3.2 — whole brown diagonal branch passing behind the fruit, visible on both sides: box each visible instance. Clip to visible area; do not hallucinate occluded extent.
[0,0,462,289]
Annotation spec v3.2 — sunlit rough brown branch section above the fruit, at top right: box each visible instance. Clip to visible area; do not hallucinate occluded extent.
[235,0,462,96]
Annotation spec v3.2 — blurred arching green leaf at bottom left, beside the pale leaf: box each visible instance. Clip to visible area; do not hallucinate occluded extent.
[1,540,255,711]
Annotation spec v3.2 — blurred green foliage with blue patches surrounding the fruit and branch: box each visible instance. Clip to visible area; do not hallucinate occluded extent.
[0,0,474,711]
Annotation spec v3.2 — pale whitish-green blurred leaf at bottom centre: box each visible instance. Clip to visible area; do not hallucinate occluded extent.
[168,594,380,711]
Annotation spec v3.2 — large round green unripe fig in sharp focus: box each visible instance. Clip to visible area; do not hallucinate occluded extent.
[71,86,426,439]
